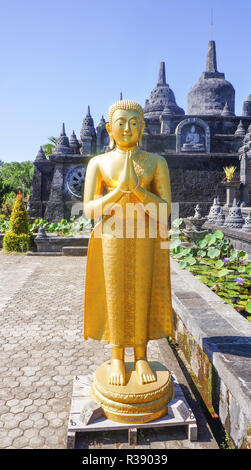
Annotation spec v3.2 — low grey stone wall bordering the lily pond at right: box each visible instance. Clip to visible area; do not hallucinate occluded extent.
[171,260,251,448]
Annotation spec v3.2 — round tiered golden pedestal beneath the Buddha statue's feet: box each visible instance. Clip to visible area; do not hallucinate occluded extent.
[91,359,174,424]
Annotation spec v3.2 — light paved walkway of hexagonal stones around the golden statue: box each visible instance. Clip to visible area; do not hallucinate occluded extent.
[0,252,218,449]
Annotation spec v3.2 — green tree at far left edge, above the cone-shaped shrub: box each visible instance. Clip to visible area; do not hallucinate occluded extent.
[0,161,34,196]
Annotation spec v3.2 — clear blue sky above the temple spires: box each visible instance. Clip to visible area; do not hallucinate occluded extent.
[0,0,251,162]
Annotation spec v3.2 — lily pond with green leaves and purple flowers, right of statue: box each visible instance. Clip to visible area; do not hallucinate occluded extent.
[170,219,251,322]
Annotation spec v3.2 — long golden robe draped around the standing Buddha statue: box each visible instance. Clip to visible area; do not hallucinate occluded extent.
[84,152,173,347]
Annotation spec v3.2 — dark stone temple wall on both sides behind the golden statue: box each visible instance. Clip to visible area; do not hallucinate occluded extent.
[30,115,251,221]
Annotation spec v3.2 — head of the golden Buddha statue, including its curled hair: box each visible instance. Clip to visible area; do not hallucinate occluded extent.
[106,100,145,150]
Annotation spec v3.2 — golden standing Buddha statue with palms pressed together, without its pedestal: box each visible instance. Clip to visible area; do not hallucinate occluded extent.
[84,100,173,422]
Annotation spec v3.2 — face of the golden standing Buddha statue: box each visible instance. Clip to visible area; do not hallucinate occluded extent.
[109,109,144,150]
